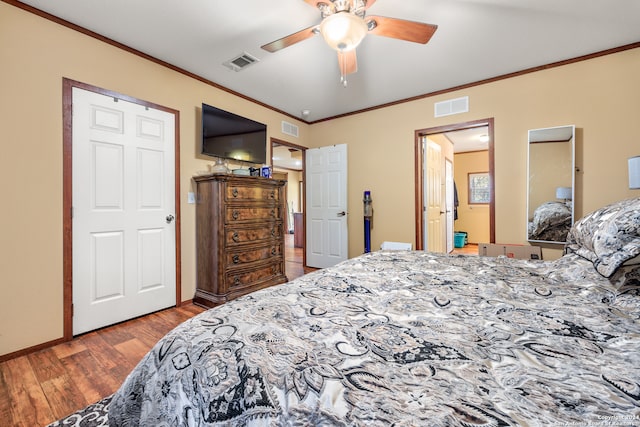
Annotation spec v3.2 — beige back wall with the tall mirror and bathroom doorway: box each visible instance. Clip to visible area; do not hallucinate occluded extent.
[310,49,640,259]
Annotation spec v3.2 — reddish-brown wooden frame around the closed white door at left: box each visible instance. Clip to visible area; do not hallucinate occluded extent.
[62,77,182,341]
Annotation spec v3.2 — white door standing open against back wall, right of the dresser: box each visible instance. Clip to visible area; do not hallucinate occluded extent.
[305,144,349,268]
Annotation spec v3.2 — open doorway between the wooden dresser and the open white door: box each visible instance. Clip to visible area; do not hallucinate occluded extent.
[270,138,307,280]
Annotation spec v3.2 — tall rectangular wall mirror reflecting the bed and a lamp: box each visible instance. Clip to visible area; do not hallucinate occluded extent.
[527,125,575,244]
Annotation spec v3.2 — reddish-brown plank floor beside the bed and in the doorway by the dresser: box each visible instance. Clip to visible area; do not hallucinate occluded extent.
[0,234,315,427]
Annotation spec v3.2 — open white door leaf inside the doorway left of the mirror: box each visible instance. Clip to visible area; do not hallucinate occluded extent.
[424,139,446,252]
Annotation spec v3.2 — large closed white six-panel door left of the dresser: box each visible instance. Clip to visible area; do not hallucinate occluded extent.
[72,88,176,335]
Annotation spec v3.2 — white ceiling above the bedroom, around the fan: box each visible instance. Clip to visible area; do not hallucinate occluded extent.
[17,0,640,122]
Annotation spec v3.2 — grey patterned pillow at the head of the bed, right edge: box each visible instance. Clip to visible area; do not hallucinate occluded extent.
[565,198,640,277]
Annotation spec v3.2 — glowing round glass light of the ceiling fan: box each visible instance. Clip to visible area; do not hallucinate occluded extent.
[320,12,368,52]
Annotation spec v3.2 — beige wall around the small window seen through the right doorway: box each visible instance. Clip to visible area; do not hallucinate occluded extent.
[453,151,490,243]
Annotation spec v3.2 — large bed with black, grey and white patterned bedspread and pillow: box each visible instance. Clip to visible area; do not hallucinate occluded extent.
[109,199,640,426]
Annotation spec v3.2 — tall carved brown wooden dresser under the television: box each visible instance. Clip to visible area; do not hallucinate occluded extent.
[193,174,287,307]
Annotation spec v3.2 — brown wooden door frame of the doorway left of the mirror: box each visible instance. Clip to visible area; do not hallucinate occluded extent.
[414,117,496,250]
